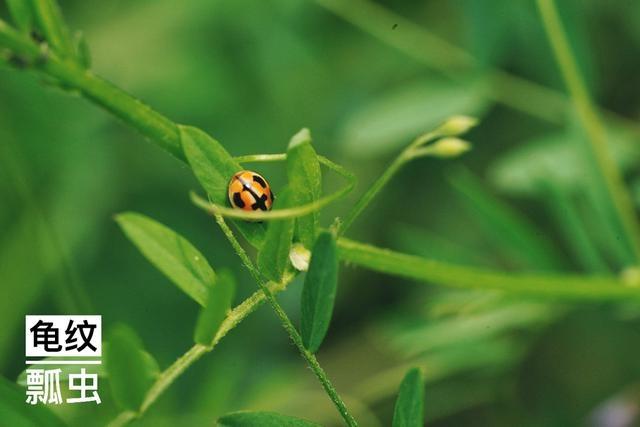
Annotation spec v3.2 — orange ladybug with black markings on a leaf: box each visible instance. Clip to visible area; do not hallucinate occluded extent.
[229,170,275,211]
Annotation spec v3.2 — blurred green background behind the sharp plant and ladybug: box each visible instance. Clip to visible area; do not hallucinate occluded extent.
[0,0,640,427]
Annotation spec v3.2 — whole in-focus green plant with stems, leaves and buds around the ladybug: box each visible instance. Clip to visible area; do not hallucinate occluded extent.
[5,1,640,425]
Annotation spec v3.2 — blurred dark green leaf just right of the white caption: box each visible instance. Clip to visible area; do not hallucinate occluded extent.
[104,324,159,411]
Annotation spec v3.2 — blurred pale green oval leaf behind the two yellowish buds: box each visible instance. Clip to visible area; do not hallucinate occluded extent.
[341,79,488,158]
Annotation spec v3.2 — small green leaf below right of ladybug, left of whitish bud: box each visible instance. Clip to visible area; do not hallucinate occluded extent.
[258,188,295,282]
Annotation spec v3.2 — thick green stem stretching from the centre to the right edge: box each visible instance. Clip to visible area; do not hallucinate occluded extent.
[338,238,640,302]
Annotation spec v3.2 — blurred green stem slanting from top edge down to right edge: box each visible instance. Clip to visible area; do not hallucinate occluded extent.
[537,0,640,261]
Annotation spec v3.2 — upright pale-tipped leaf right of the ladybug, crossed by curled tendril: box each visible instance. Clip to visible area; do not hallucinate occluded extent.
[287,129,322,248]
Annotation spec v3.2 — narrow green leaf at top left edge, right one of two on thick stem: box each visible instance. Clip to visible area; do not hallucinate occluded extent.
[31,0,75,57]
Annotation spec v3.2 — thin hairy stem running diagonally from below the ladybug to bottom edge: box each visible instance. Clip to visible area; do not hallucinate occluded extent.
[215,214,358,426]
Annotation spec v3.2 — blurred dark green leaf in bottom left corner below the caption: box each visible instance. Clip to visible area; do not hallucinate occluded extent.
[0,376,65,427]
